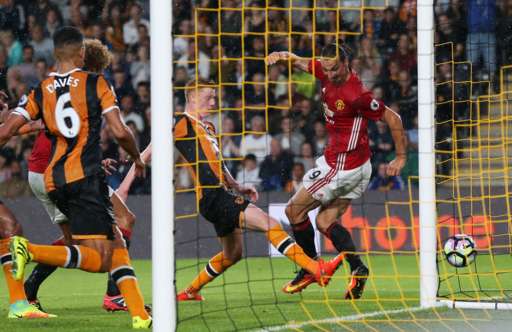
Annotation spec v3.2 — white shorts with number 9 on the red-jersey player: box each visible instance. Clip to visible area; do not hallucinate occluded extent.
[302,156,372,205]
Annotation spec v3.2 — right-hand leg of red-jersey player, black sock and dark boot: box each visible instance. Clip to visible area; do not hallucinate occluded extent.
[316,198,369,299]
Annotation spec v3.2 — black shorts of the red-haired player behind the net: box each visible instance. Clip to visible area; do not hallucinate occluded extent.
[199,188,250,237]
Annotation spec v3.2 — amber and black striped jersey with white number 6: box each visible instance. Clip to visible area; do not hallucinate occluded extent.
[14,68,118,192]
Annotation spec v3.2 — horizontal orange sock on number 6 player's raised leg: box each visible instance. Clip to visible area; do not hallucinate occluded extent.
[28,243,101,272]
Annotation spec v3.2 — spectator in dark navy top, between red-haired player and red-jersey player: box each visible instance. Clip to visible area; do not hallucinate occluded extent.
[260,139,293,191]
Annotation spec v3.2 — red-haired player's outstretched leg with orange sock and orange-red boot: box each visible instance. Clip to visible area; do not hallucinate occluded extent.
[240,204,341,286]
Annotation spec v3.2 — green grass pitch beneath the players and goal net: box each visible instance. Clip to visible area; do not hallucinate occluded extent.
[0,255,512,332]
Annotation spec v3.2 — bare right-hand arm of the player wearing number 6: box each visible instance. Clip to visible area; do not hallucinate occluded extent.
[104,108,145,176]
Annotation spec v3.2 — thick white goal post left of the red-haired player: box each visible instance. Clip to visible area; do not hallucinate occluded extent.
[150,0,176,332]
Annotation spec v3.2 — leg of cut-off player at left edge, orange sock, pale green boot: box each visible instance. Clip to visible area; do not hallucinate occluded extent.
[0,203,55,318]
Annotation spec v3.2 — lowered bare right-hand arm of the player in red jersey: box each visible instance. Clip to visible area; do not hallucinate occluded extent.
[382,107,407,176]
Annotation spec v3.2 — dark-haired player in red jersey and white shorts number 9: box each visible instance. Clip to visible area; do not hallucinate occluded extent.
[267,44,406,299]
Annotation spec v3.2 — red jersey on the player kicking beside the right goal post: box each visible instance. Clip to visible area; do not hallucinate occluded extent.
[309,60,384,170]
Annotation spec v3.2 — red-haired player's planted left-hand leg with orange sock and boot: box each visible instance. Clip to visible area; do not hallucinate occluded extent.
[177,228,243,301]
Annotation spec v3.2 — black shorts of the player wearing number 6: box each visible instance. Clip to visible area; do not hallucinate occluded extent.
[48,175,115,240]
